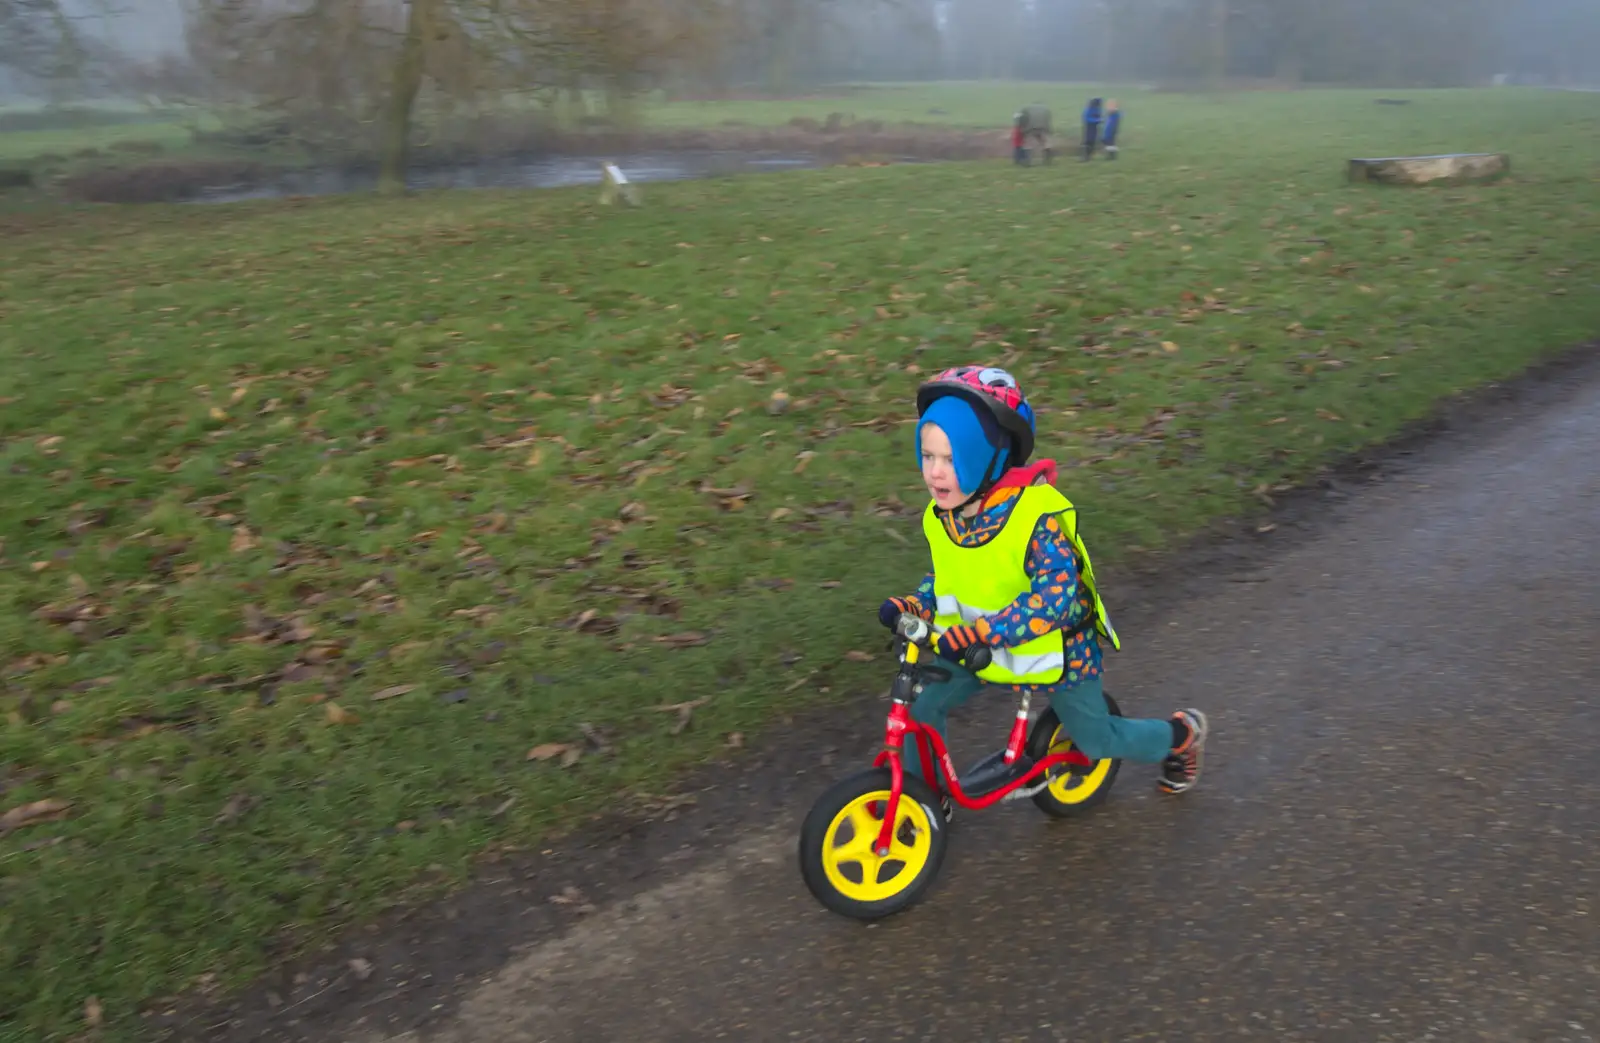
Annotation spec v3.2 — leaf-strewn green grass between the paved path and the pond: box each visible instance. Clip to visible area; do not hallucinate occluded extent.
[0,90,1600,1041]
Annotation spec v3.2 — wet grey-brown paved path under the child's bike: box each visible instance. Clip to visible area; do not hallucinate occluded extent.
[352,374,1600,1043]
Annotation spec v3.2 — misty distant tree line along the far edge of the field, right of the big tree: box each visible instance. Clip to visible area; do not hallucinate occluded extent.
[720,0,1600,86]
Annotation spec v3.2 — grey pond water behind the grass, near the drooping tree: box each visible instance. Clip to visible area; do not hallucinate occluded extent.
[189,150,824,203]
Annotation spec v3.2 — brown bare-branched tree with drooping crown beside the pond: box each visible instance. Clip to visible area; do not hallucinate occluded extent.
[187,0,722,192]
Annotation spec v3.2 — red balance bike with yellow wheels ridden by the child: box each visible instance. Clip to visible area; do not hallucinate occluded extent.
[800,613,1122,920]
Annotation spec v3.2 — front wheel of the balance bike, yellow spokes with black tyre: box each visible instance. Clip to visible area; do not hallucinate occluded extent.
[800,768,949,920]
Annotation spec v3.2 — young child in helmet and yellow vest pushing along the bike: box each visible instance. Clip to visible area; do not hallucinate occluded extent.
[878,366,1206,816]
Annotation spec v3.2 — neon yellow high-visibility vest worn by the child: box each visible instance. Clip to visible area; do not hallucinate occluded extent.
[922,485,1122,685]
